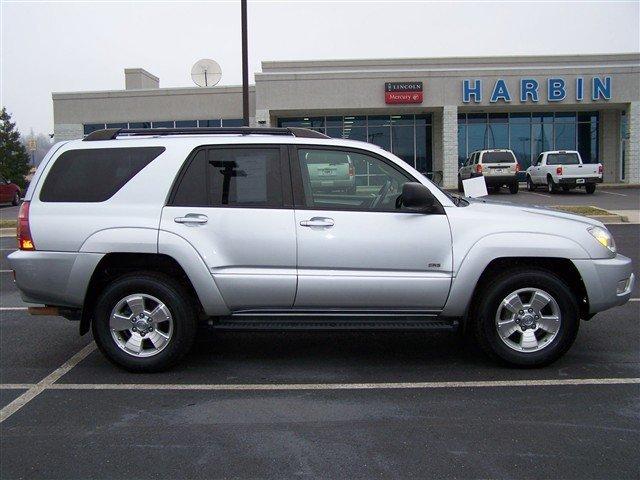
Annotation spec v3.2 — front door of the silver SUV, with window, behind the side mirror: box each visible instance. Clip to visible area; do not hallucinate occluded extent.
[291,146,452,311]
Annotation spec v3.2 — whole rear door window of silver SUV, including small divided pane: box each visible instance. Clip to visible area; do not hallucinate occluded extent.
[171,147,283,208]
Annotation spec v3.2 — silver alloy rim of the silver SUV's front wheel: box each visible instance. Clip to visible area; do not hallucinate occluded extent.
[495,288,562,353]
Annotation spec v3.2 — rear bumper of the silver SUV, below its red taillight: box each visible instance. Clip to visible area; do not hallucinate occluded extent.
[8,250,104,307]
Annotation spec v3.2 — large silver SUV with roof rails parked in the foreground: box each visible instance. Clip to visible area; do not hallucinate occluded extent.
[9,128,634,371]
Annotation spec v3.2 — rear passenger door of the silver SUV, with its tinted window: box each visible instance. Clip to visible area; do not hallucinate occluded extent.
[161,145,296,311]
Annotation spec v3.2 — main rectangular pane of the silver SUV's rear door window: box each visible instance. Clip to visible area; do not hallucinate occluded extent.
[207,147,282,207]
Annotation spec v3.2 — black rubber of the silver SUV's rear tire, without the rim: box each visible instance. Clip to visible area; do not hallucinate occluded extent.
[92,272,198,372]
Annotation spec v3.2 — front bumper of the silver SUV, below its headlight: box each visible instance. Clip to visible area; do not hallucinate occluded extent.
[573,254,635,314]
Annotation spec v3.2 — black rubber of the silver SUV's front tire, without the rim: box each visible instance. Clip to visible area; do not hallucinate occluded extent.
[471,268,580,367]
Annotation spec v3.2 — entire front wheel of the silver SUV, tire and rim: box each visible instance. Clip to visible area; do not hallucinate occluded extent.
[473,269,580,367]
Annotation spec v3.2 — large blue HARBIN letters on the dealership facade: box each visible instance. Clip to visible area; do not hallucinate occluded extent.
[460,77,612,103]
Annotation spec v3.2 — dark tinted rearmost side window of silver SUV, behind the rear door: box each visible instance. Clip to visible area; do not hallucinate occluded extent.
[40,147,165,202]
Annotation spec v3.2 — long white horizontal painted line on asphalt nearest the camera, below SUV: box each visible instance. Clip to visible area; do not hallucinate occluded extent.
[48,378,640,391]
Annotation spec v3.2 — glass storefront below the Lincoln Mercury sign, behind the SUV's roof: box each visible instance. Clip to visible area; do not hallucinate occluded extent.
[278,115,433,175]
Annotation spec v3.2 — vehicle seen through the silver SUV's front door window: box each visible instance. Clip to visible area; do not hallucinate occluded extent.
[306,151,356,194]
